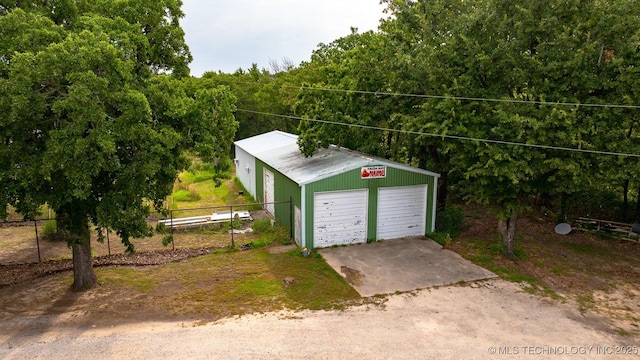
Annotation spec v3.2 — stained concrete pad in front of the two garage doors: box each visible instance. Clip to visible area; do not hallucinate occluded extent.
[318,237,497,296]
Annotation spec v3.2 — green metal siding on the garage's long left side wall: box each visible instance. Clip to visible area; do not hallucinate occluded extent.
[256,159,302,232]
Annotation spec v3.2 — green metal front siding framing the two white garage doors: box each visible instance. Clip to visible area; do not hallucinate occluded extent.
[303,165,435,247]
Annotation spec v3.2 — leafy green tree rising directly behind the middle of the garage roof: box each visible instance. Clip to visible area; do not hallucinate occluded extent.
[293,29,407,162]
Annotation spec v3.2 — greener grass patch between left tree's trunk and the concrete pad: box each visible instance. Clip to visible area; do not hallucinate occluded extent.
[97,249,360,318]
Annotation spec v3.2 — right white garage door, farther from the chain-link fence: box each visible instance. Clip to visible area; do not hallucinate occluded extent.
[377,185,427,240]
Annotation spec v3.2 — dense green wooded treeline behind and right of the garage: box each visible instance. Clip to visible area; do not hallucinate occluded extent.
[211,0,640,253]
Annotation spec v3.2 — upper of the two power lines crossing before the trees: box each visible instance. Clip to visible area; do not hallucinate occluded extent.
[219,80,640,110]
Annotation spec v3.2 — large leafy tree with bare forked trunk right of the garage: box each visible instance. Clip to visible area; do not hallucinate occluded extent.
[390,0,637,255]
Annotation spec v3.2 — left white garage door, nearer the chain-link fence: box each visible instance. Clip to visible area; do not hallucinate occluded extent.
[313,189,369,248]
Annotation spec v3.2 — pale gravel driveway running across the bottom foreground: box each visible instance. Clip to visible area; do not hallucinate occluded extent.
[0,279,640,360]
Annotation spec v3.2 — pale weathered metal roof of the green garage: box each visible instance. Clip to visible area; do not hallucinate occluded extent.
[235,131,440,185]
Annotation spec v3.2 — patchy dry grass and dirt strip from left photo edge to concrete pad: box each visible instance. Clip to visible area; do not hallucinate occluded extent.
[0,248,361,326]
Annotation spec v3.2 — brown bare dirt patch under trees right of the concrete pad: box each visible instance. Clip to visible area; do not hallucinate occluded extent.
[449,206,640,336]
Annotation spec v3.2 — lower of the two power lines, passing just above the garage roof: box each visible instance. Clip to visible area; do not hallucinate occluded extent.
[236,109,640,158]
